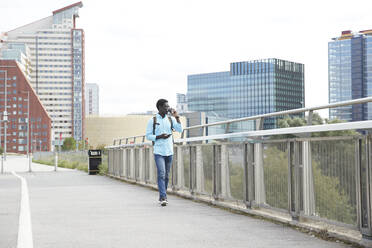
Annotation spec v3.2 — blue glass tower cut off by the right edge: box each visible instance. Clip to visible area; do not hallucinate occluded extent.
[328,30,372,121]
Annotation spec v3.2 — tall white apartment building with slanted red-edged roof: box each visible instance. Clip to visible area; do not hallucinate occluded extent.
[0,2,85,140]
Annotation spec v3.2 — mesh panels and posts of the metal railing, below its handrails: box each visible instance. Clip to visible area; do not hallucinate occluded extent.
[108,135,371,228]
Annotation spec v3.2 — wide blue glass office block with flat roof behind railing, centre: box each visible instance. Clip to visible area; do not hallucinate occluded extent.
[187,58,305,129]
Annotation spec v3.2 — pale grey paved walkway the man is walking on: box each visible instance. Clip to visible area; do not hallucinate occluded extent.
[0,158,349,248]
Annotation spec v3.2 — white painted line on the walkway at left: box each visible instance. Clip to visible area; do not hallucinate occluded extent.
[12,171,34,248]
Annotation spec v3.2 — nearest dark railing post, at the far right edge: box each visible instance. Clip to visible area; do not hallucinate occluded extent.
[355,134,372,247]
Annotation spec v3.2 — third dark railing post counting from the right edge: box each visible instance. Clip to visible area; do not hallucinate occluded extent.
[244,143,254,208]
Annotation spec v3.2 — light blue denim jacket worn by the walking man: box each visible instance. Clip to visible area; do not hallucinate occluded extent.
[146,114,182,156]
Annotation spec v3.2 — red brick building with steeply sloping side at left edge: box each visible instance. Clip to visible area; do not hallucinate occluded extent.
[0,59,51,154]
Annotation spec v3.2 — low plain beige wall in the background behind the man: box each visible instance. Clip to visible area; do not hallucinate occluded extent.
[85,115,186,148]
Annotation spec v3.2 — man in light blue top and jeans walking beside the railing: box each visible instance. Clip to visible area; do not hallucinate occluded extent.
[146,99,182,206]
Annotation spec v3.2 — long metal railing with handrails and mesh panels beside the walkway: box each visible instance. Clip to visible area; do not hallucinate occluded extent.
[107,97,372,244]
